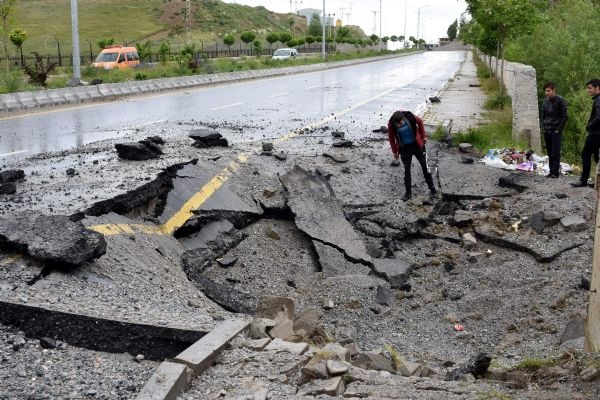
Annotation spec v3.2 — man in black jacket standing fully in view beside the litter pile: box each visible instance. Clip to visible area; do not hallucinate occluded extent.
[542,82,568,178]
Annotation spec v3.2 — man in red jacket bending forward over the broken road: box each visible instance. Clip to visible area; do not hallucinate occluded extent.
[388,111,437,201]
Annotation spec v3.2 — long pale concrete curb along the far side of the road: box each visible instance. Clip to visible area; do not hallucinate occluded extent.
[0,52,417,113]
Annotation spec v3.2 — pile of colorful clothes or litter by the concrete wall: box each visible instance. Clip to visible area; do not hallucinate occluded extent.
[479,149,571,175]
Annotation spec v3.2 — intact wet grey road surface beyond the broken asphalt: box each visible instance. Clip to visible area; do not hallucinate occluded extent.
[0,51,465,164]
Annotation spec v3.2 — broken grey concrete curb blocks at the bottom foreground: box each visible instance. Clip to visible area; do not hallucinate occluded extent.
[137,320,250,400]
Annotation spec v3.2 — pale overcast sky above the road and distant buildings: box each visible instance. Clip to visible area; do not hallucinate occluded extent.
[225,0,467,42]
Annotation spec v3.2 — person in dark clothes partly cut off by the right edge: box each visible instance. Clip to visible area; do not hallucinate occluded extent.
[571,78,600,187]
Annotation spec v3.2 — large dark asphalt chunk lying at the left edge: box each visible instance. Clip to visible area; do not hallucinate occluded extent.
[0,213,106,266]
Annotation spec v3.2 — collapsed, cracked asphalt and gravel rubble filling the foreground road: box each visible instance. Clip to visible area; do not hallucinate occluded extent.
[0,52,595,398]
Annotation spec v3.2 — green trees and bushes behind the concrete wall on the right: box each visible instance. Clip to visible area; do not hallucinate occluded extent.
[459,0,600,163]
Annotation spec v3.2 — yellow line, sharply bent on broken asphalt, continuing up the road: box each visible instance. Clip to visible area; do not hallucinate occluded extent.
[88,89,395,236]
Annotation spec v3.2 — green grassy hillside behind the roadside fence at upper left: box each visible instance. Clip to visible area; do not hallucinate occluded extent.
[14,0,306,54]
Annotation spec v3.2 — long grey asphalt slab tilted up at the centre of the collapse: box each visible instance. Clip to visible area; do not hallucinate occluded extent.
[280,165,372,266]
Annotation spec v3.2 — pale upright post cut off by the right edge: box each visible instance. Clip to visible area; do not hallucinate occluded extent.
[583,165,600,353]
